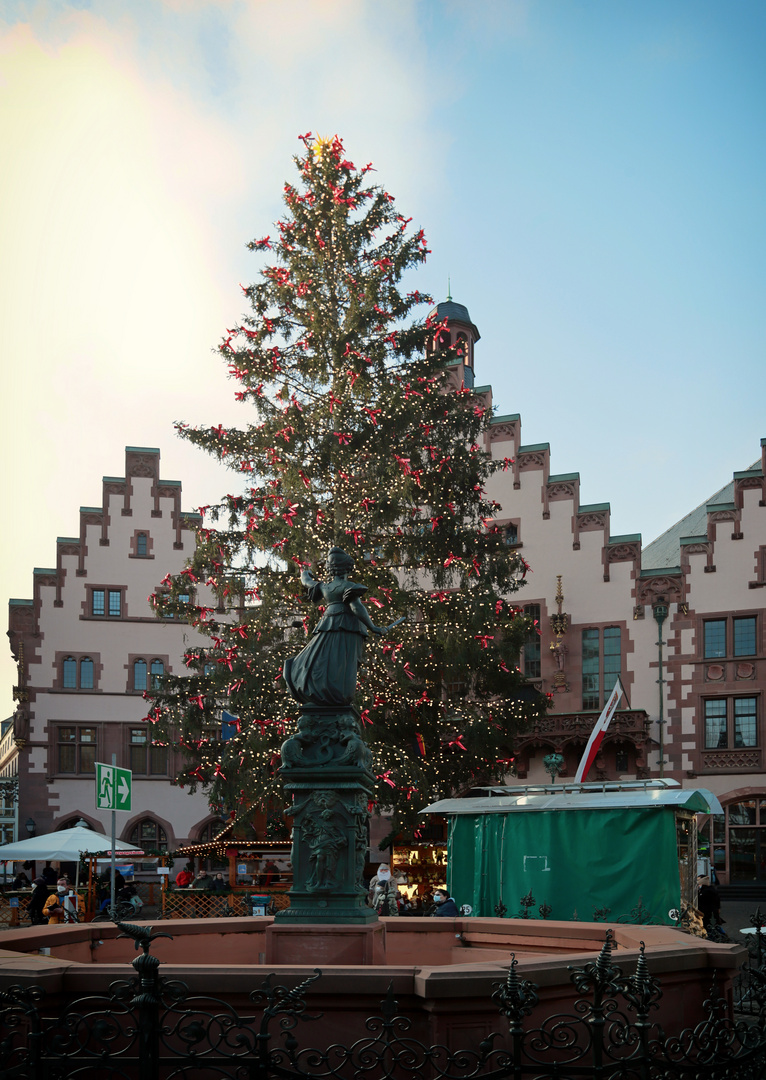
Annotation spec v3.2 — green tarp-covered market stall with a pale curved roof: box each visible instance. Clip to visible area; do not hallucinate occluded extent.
[424,780,722,923]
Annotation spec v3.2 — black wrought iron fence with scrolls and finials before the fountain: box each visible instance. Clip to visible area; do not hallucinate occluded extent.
[0,923,766,1080]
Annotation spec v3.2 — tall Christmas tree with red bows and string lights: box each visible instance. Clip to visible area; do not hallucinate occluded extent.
[147,135,546,838]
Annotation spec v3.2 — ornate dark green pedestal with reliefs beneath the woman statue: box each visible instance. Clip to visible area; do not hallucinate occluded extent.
[273,705,378,924]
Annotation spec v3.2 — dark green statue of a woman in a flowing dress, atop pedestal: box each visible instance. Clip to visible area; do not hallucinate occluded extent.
[283,548,402,705]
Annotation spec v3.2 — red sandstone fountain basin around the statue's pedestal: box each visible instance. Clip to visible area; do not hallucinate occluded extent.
[0,917,745,1048]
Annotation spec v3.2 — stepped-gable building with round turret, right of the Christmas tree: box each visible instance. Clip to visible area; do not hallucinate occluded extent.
[435,301,766,886]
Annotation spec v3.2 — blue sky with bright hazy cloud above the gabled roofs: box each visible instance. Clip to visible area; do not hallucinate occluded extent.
[0,0,766,716]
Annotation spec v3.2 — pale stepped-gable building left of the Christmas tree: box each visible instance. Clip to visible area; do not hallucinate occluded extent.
[0,447,220,851]
